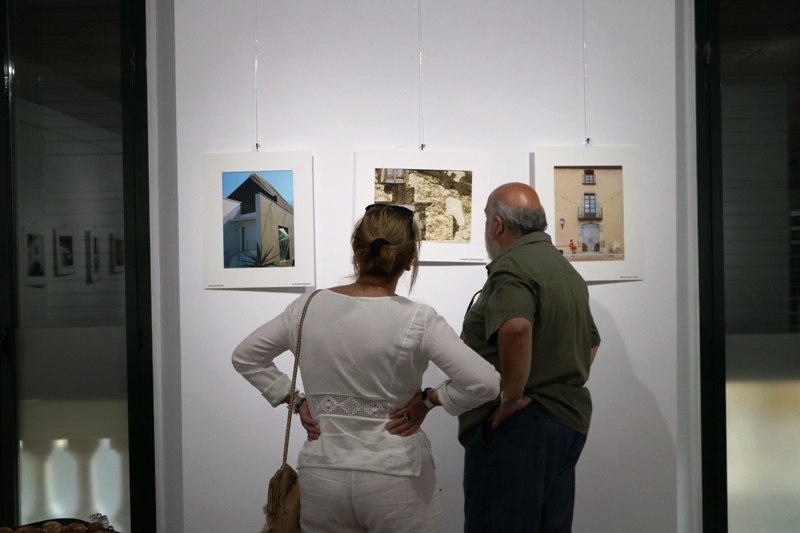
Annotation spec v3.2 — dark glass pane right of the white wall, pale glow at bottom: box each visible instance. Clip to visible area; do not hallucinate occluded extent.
[719,0,800,533]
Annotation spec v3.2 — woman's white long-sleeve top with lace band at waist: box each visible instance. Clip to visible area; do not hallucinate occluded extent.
[233,290,500,476]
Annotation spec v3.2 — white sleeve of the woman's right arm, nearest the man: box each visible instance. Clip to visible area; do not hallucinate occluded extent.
[422,308,500,416]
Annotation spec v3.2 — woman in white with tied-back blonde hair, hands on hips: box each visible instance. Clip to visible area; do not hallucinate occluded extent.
[233,204,499,533]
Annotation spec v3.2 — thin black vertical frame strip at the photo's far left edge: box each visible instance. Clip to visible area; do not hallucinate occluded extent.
[0,0,19,524]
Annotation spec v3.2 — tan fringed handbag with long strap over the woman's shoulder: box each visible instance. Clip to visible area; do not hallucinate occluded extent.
[261,289,319,533]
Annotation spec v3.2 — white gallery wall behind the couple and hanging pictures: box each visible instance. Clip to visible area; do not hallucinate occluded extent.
[148,0,697,533]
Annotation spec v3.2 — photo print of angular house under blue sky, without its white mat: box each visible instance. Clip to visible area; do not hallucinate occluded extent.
[222,171,295,268]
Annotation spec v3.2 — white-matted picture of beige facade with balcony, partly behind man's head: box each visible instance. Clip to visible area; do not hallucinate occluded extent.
[530,143,644,281]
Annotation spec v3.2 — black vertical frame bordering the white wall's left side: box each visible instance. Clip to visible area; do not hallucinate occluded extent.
[121,0,156,531]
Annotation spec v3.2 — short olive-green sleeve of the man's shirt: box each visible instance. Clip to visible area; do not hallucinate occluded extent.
[481,268,536,343]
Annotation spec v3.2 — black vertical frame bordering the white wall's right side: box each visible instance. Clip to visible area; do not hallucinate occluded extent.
[695,0,728,533]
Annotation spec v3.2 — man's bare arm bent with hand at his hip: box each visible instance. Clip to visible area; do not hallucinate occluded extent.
[491,318,533,428]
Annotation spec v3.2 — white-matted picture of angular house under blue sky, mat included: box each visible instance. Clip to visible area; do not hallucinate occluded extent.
[203,151,315,289]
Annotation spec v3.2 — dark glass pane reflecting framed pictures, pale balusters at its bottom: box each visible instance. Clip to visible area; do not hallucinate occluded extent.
[8,0,130,532]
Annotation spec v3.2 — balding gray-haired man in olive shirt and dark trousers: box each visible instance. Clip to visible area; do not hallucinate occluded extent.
[458,183,600,533]
